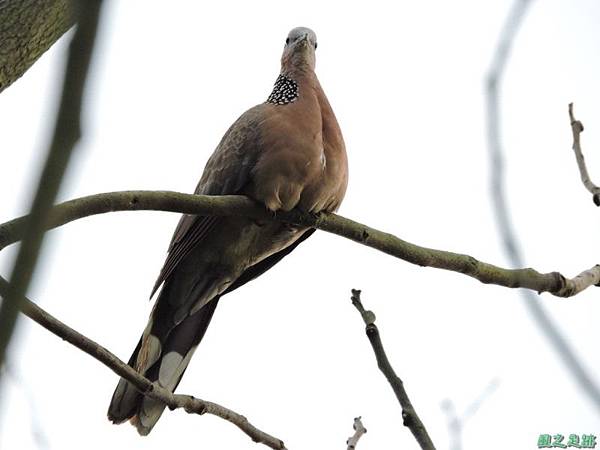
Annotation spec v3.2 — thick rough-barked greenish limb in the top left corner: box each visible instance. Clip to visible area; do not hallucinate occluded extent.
[0,0,74,92]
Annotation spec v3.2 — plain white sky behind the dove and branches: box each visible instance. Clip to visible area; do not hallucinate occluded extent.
[0,0,600,450]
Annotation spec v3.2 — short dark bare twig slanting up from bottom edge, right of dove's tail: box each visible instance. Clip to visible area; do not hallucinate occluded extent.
[352,289,435,450]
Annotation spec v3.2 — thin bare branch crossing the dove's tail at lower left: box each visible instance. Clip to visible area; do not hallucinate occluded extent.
[0,277,285,450]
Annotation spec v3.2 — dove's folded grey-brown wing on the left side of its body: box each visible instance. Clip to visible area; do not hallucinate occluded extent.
[150,105,263,297]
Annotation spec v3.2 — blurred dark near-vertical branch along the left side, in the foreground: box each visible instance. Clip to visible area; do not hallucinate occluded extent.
[0,0,101,372]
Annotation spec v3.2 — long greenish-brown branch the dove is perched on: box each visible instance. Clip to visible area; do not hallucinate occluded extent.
[0,191,600,297]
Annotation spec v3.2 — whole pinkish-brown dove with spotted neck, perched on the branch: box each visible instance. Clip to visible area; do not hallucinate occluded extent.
[108,28,348,435]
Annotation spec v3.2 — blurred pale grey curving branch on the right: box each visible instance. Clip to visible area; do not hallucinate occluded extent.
[486,0,600,411]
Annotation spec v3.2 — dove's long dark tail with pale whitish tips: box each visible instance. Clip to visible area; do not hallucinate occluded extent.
[108,297,219,436]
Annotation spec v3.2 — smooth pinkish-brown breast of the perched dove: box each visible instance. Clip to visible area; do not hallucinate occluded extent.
[249,74,347,212]
